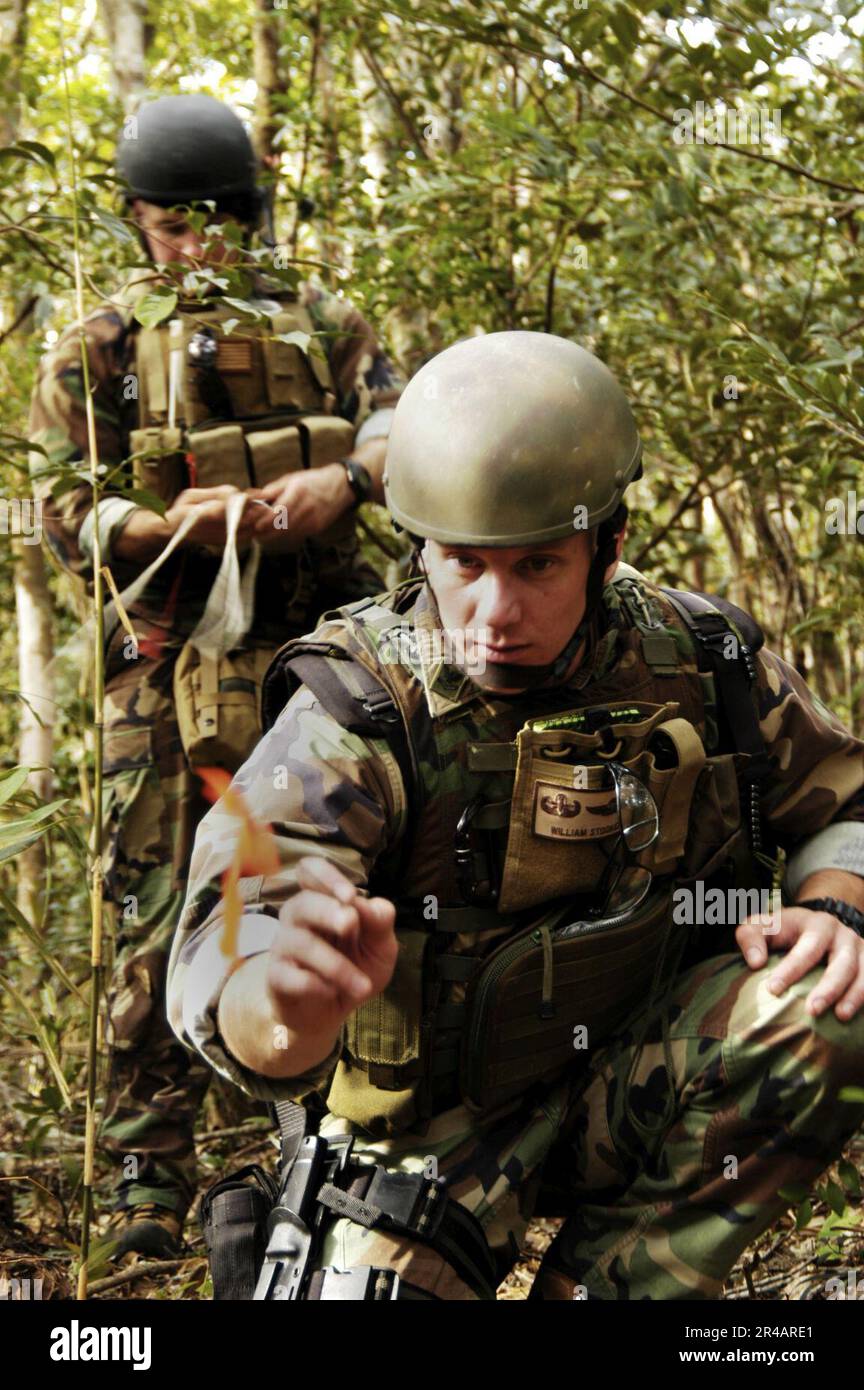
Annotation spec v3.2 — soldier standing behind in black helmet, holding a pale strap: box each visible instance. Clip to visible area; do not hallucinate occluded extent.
[31,97,401,1255]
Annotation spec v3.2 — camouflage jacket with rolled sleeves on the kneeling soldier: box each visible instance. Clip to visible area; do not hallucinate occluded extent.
[167,585,864,1131]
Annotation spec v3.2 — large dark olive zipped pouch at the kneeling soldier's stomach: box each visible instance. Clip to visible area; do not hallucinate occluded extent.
[460,890,672,1113]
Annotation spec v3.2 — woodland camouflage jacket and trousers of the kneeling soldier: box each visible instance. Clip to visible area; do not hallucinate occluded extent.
[168,572,864,1300]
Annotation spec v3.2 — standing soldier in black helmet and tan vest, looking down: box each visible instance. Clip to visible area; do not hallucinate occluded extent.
[31,96,401,1255]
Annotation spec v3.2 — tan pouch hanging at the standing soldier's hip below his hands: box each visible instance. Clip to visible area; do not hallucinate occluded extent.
[174,642,272,773]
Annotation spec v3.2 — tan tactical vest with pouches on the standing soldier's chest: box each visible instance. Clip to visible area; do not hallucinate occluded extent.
[125,276,354,542]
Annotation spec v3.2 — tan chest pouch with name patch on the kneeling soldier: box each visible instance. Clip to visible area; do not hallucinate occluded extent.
[497,702,686,912]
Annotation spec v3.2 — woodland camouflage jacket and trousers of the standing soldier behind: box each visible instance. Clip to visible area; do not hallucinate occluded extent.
[31,277,400,1216]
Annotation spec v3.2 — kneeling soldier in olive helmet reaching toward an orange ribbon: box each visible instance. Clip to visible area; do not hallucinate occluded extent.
[168,332,864,1300]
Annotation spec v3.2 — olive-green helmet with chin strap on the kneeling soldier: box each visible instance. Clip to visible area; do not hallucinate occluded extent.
[385,332,642,688]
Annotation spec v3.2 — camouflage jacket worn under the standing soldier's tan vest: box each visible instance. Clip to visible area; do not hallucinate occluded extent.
[29,266,403,644]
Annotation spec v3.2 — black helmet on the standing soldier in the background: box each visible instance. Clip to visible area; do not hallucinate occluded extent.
[117,96,261,222]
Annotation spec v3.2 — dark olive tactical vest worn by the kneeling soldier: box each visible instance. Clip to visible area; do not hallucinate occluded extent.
[264,571,765,1134]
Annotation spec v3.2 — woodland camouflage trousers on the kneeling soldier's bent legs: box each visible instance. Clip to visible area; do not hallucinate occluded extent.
[311,955,864,1300]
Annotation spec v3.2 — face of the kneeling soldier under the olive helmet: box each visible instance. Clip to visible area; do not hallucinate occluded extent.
[424,531,624,694]
